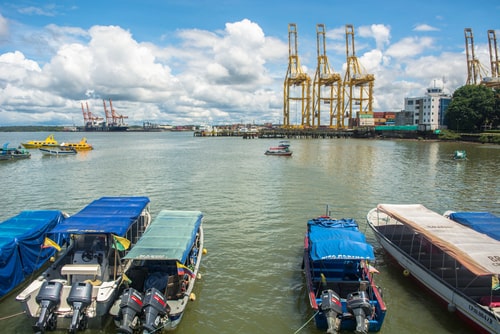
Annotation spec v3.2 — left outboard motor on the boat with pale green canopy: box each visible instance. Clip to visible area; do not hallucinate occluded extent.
[116,288,143,334]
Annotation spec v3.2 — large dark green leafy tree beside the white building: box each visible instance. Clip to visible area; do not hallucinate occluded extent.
[445,85,500,133]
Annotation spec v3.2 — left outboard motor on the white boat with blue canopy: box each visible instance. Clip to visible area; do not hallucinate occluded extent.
[33,281,63,333]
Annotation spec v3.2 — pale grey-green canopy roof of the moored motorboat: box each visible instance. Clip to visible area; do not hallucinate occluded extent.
[125,210,203,263]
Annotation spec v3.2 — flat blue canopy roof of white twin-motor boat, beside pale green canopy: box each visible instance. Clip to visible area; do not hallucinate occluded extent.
[52,197,149,236]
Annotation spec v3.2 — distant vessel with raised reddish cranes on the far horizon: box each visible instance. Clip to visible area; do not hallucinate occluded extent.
[78,99,128,132]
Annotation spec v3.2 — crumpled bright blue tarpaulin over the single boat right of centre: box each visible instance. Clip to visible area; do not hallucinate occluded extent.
[308,218,375,261]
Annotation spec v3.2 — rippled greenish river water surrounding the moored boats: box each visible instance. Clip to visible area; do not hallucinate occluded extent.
[0,132,500,334]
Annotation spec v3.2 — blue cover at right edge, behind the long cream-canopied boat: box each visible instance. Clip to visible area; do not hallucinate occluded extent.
[450,212,500,240]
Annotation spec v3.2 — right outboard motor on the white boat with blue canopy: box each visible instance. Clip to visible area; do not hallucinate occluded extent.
[66,282,92,333]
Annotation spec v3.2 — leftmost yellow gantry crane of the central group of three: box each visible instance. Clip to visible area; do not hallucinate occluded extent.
[283,23,311,128]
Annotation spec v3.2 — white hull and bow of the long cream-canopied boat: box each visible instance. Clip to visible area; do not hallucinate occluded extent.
[367,209,500,333]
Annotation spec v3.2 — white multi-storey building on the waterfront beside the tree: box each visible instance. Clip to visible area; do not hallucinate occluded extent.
[404,87,451,131]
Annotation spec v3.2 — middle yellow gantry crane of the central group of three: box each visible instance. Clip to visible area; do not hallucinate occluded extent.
[312,24,344,129]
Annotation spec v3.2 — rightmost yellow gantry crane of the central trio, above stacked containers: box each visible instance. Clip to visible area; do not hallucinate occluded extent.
[342,24,375,127]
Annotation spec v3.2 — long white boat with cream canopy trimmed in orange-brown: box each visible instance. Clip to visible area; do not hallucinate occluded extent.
[367,204,500,333]
